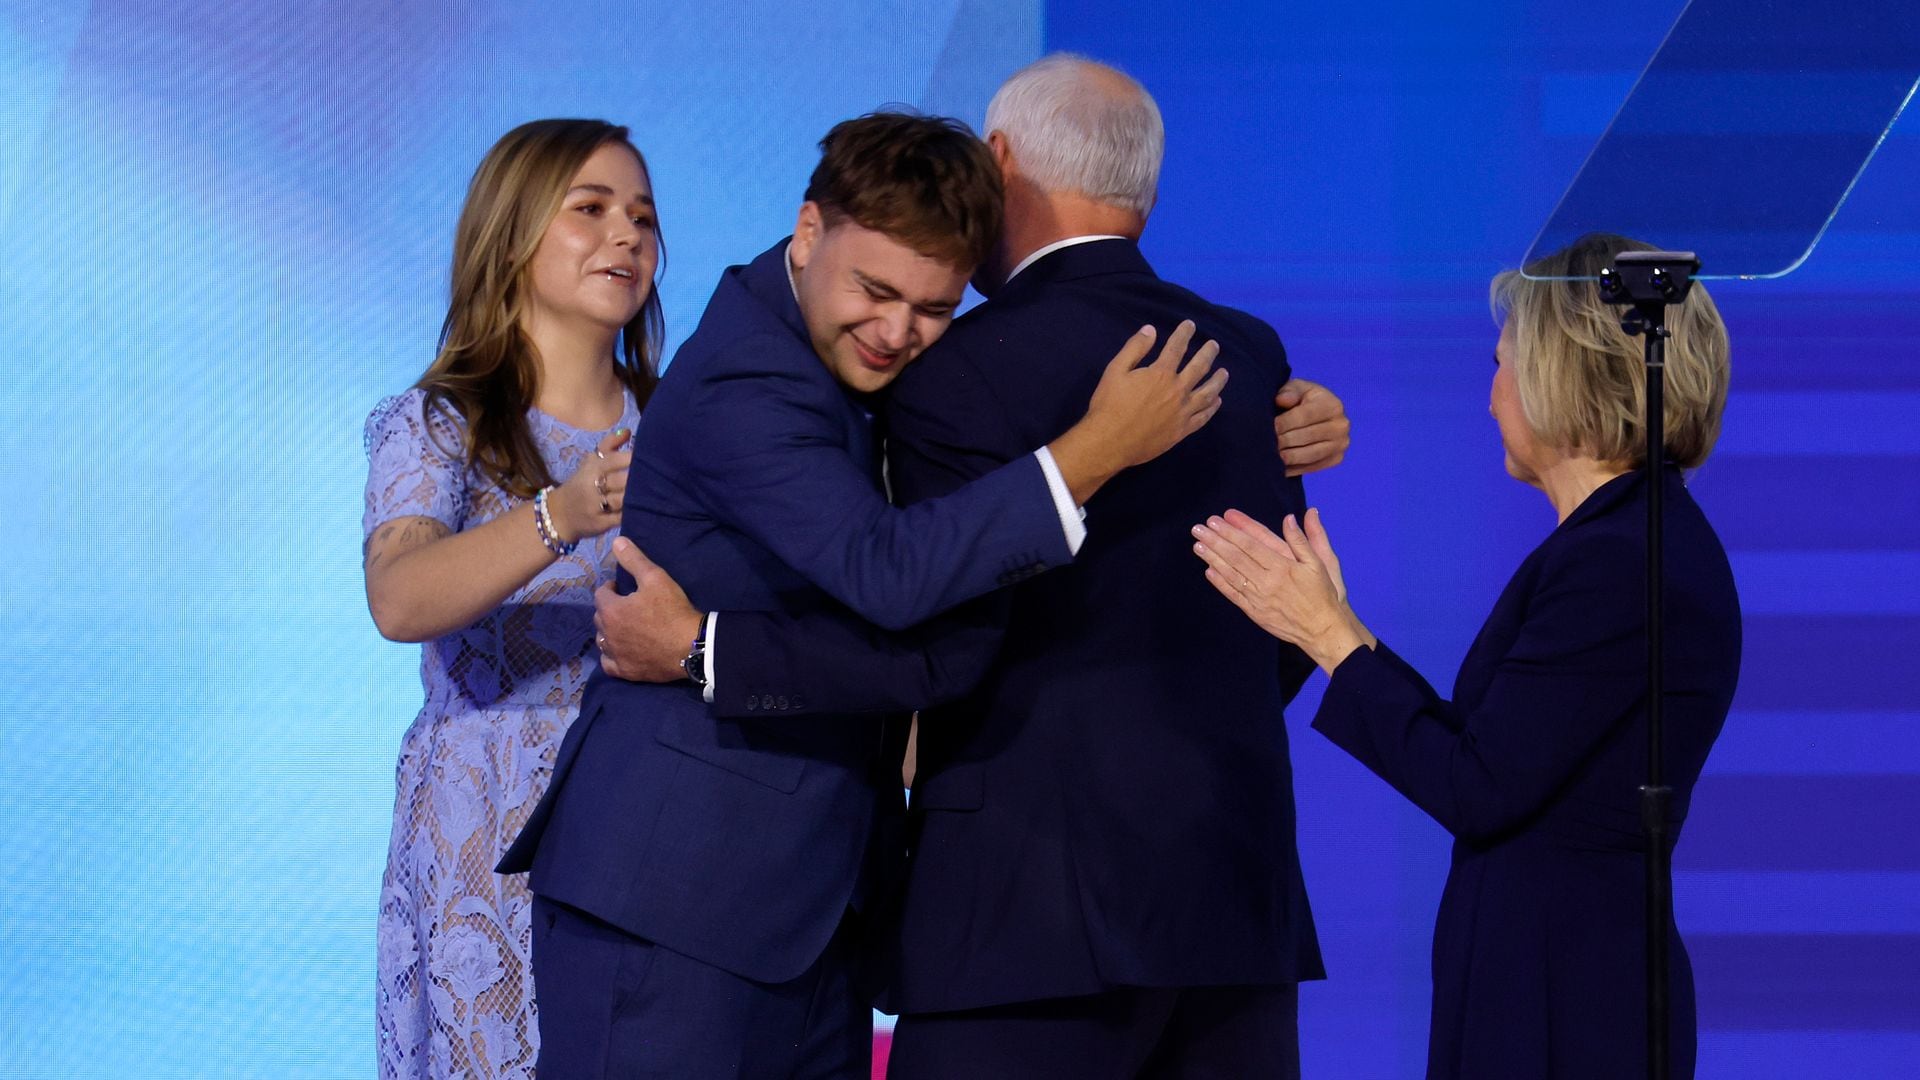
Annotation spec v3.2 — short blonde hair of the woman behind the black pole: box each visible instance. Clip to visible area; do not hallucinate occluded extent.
[1490,233,1730,469]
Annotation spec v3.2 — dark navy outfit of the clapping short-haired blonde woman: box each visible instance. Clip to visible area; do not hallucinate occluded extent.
[1313,469,1740,1080]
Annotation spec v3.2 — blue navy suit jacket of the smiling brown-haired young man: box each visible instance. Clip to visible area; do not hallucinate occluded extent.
[499,242,1071,982]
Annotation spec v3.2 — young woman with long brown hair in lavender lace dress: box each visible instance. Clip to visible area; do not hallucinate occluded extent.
[363,119,662,1080]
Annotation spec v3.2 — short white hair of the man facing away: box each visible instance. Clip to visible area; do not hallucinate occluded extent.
[987,52,1167,215]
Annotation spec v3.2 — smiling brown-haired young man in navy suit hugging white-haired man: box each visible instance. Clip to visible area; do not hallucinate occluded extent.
[499,113,1225,1080]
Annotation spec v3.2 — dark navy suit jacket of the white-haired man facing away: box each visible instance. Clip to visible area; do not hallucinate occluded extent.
[716,240,1323,1013]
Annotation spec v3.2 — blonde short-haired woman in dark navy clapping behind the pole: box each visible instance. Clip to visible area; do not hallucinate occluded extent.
[1194,236,1740,1080]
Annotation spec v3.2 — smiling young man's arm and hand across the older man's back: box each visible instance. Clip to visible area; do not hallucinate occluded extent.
[693,323,1227,630]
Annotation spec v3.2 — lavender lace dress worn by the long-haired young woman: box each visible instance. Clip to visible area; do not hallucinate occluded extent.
[363,390,639,1080]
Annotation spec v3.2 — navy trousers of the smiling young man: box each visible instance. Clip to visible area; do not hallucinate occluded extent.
[534,896,874,1080]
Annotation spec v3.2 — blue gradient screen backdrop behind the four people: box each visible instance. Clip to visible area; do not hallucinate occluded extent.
[0,0,1920,1080]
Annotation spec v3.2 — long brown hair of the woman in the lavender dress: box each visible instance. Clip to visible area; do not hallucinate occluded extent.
[417,119,666,498]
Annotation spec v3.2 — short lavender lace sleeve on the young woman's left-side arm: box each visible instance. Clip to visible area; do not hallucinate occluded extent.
[361,388,467,538]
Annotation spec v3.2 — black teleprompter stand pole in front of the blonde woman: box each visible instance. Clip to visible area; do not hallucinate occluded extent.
[1599,252,1699,1080]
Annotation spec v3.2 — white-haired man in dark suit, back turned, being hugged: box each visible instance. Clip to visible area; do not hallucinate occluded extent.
[601,58,1346,1080]
